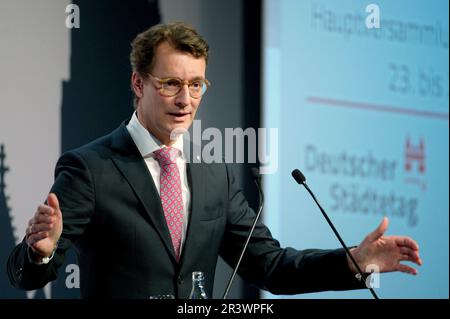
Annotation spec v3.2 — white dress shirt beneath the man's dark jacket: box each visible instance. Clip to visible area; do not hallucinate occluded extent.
[127,112,191,253]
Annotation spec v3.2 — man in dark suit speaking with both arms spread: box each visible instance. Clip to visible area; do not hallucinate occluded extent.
[8,23,421,298]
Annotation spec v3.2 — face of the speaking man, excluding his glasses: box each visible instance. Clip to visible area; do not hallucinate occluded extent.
[137,42,206,145]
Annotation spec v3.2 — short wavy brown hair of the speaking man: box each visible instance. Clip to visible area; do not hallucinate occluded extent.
[130,22,209,108]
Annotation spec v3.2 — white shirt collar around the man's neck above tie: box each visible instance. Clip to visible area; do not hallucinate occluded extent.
[127,112,184,158]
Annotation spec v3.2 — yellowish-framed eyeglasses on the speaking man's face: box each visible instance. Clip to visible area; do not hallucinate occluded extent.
[148,73,211,99]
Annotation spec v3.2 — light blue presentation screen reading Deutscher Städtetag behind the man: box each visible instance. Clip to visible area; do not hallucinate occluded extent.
[263,0,449,298]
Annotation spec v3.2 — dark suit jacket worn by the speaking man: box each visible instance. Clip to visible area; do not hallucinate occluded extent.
[8,123,362,298]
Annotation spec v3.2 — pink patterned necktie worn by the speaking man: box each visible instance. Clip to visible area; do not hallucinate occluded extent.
[153,147,183,261]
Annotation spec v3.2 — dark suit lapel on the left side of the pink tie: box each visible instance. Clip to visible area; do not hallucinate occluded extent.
[112,124,175,260]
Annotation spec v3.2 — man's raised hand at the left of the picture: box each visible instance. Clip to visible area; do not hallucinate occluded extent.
[26,193,62,258]
